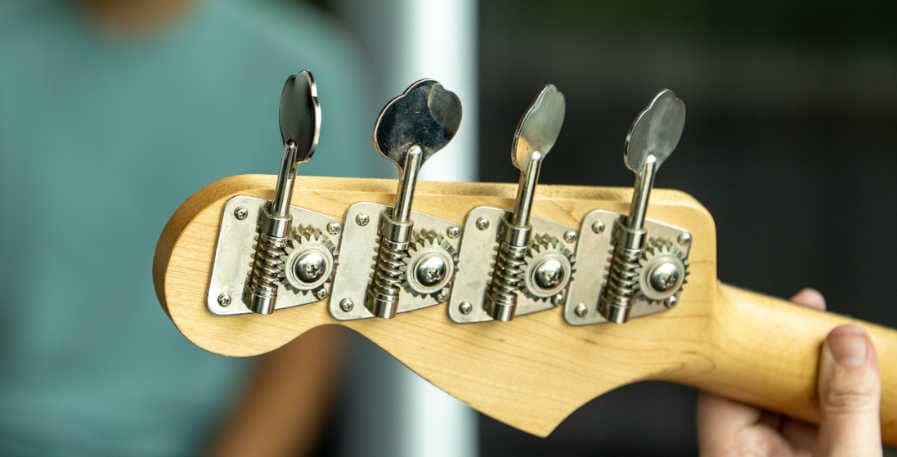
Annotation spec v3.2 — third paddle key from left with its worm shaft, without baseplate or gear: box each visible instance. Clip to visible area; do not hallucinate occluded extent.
[484,84,566,321]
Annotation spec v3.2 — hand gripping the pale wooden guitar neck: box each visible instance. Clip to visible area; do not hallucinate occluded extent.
[698,289,882,457]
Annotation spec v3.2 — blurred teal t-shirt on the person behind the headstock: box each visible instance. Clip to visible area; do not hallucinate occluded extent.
[0,0,377,456]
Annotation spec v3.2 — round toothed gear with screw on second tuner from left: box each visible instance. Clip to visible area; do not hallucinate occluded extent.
[403,230,458,298]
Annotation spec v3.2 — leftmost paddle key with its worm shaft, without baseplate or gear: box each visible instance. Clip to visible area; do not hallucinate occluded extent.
[244,70,321,314]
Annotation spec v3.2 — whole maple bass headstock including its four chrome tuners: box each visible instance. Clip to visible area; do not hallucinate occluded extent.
[154,72,718,435]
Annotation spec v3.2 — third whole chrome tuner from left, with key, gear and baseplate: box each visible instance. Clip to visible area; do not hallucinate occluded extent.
[449,84,577,323]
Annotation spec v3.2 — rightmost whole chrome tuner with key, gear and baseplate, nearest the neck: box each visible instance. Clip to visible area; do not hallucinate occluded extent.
[564,90,692,325]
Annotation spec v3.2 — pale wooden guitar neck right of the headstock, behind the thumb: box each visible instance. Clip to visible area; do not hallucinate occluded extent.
[656,284,897,445]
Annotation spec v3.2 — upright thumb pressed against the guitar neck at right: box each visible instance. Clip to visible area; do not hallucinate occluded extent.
[818,325,882,457]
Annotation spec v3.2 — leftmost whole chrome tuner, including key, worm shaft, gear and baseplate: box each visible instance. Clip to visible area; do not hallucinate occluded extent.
[206,71,342,315]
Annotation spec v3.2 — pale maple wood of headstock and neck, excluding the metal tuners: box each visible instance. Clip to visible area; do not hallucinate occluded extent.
[153,175,897,444]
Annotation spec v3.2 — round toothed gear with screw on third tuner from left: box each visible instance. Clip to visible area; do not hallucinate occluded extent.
[521,234,574,301]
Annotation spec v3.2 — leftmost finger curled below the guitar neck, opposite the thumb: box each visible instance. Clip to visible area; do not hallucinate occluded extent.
[698,393,762,455]
